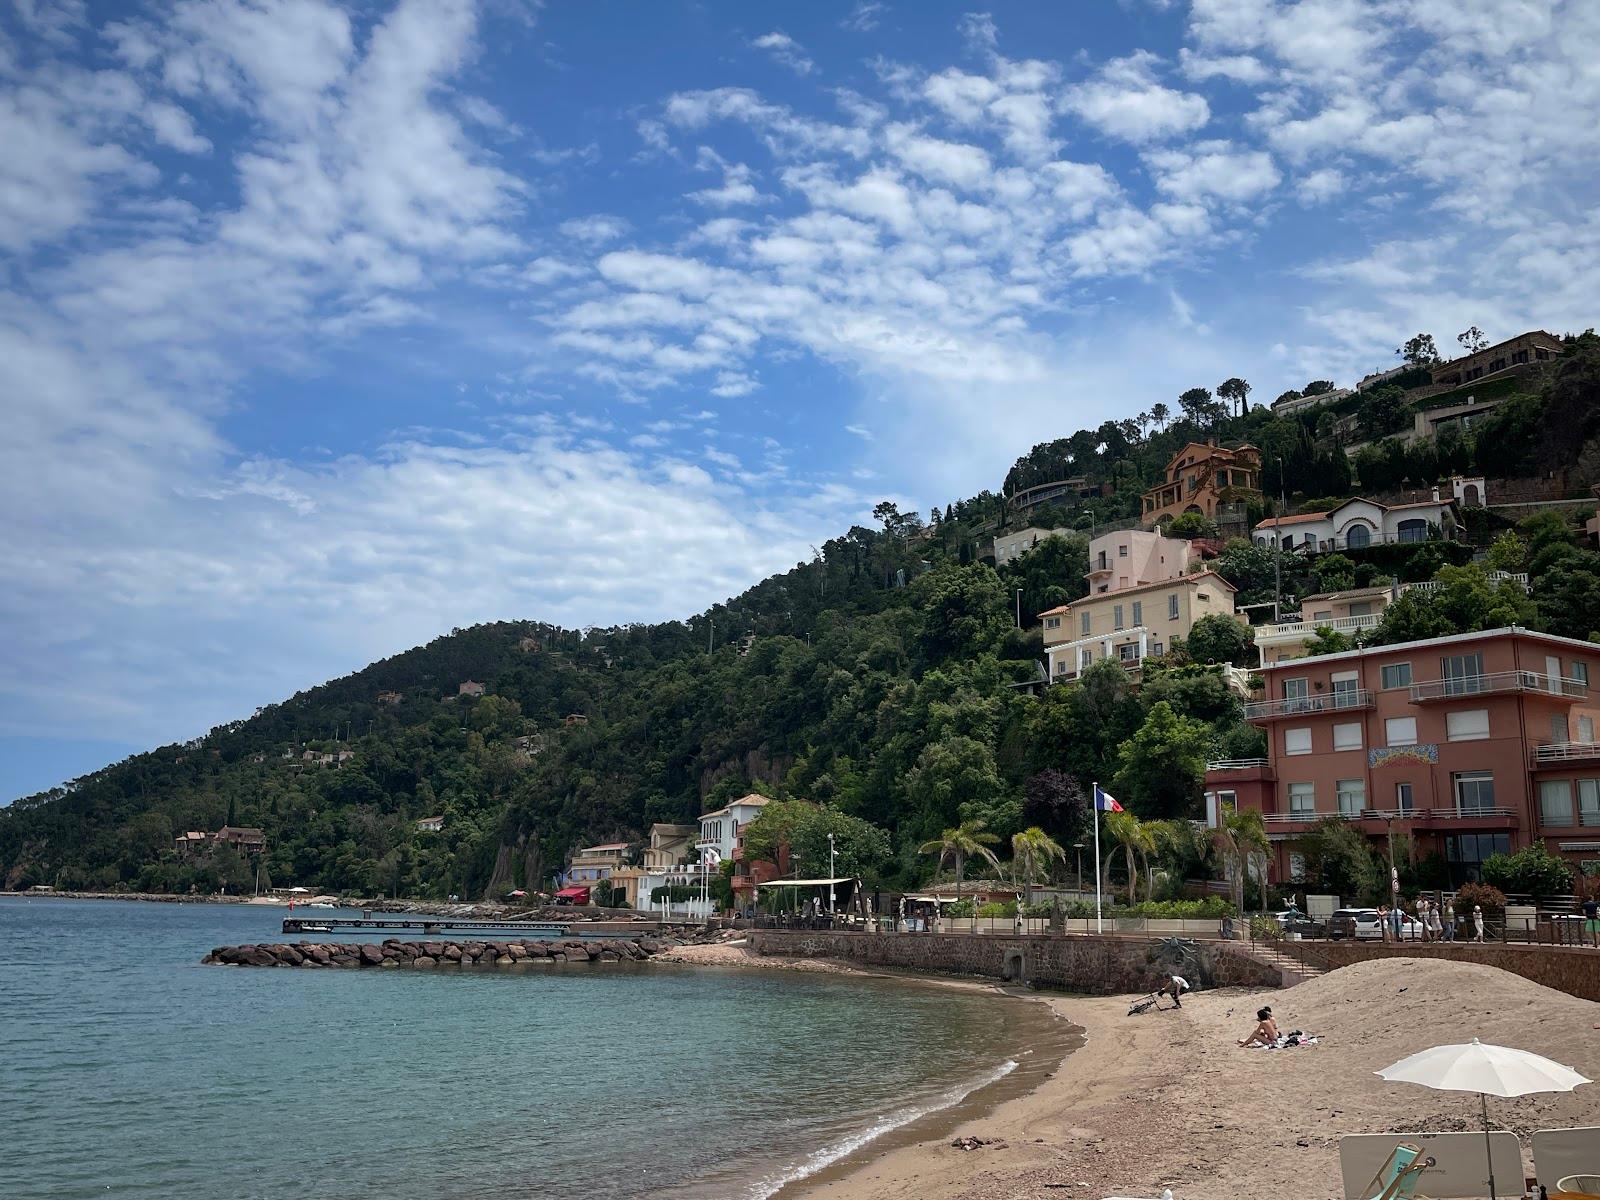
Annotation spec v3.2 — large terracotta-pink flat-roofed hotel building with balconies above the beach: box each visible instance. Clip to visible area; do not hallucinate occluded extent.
[1205,627,1600,883]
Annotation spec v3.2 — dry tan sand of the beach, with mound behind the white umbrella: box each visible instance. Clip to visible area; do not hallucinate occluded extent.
[633,946,1600,1200]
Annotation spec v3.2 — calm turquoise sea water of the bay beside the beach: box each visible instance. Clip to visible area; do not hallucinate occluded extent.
[0,899,1034,1200]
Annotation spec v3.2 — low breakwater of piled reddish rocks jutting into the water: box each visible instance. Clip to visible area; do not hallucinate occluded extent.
[200,931,715,968]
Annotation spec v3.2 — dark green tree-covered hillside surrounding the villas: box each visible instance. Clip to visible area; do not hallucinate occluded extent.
[9,334,1600,896]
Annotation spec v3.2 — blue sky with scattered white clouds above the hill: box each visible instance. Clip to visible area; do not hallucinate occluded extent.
[0,0,1600,802]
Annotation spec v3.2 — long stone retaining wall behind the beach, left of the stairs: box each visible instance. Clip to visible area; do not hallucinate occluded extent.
[749,930,1282,995]
